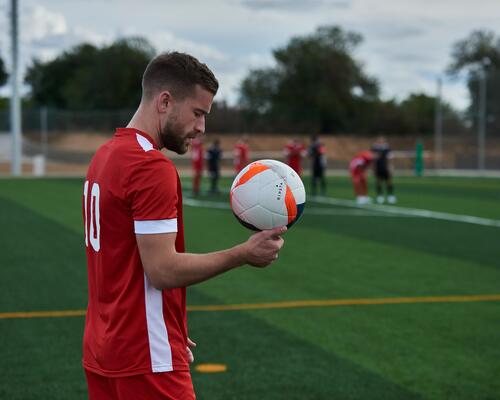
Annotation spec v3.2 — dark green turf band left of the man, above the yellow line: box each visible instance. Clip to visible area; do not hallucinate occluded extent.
[0,197,87,312]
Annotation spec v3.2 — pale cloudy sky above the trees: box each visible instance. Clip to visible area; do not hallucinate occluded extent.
[0,0,500,108]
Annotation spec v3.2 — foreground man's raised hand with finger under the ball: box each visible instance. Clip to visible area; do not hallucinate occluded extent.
[244,226,287,268]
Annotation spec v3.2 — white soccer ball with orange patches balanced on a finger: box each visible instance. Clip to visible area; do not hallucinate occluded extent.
[230,160,306,231]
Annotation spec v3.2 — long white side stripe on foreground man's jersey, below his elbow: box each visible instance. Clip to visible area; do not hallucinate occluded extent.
[144,274,174,372]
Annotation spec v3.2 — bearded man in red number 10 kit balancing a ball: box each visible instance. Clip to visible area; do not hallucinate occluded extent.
[83,52,286,400]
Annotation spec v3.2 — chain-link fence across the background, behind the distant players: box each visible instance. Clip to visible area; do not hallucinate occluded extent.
[0,97,500,174]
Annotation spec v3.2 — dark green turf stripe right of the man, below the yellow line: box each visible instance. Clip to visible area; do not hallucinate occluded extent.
[188,288,421,400]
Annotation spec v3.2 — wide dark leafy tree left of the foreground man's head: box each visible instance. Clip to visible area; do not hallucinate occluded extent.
[26,38,155,110]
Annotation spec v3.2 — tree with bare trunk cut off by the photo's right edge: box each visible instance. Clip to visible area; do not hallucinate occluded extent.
[448,30,500,130]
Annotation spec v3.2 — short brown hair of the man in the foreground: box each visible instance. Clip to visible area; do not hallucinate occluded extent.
[142,51,219,100]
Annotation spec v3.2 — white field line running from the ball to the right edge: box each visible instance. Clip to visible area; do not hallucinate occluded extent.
[313,196,500,228]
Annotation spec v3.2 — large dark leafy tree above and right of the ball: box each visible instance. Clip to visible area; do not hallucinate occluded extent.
[240,26,378,133]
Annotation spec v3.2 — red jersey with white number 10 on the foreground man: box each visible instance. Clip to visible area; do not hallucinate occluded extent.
[83,128,189,377]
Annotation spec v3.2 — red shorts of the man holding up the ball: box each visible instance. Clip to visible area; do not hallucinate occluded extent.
[85,370,196,400]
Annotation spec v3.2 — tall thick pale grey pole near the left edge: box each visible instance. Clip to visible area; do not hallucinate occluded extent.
[10,0,22,176]
